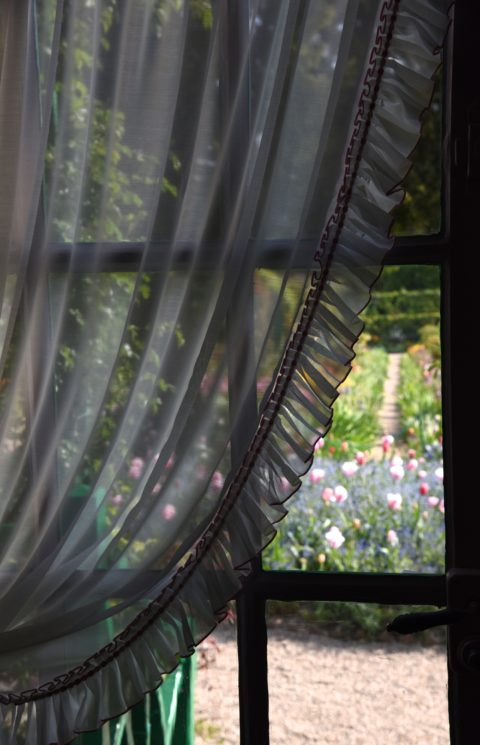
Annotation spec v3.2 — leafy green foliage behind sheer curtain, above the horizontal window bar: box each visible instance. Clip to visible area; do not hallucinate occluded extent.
[45,0,189,242]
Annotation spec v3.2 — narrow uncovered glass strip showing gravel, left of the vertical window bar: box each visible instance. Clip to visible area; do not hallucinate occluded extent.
[195,606,240,745]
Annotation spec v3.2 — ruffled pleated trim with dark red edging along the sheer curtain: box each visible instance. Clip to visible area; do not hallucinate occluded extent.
[0,0,447,745]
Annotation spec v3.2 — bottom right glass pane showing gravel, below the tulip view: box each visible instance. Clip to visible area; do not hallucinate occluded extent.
[267,601,450,745]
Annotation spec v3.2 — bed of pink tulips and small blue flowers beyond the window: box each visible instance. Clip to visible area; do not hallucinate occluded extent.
[264,436,445,573]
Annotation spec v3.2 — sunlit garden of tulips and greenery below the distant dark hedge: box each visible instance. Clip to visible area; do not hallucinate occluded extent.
[264,326,444,572]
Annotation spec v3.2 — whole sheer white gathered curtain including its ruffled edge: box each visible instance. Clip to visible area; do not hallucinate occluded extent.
[0,0,447,745]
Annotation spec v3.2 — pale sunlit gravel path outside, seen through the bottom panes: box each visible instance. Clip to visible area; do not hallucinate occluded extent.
[195,627,449,745]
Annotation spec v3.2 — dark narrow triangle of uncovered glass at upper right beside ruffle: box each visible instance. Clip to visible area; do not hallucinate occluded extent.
[393,75,442,235]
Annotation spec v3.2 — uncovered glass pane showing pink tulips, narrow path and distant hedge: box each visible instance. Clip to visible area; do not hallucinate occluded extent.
[264,267,445,573]
